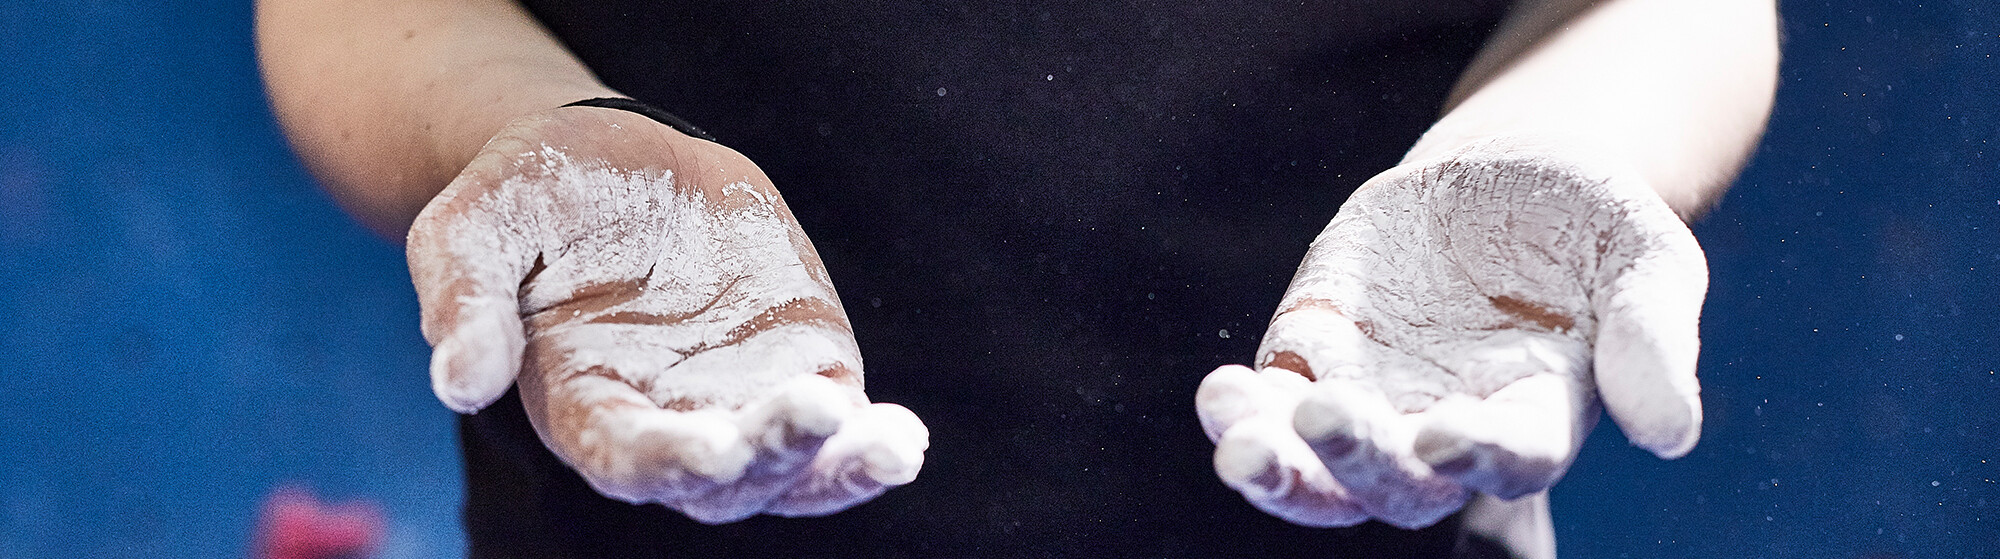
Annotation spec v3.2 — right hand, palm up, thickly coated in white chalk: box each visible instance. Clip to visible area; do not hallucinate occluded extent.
[1196,140,1708,527]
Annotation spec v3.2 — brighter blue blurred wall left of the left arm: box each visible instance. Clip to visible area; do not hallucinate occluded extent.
[0,2,464,559]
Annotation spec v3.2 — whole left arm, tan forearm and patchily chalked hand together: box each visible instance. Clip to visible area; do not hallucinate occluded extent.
[258,0,928,523]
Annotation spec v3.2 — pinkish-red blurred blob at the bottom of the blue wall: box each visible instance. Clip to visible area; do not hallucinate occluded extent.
[250,487,384,559]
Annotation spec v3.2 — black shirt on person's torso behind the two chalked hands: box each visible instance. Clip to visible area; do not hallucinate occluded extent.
[462,0,1504,557]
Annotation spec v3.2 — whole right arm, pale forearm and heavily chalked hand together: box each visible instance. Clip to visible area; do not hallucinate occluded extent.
[1196,0,1778,557]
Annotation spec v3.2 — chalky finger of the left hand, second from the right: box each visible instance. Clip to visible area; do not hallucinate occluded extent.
[674,375,868,525]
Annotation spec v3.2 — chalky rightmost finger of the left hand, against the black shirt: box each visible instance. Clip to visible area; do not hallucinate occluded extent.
[766,403,930,517]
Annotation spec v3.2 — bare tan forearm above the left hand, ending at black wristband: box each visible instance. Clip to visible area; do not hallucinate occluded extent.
[256,0,616,240]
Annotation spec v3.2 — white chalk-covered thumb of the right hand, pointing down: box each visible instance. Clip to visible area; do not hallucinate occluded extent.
[1592,206,1708,459]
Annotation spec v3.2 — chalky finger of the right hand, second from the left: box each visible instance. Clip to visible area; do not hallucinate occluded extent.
[1214,409,1368,527]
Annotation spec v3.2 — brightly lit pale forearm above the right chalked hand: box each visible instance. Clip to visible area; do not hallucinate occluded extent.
[1406,0,1778,220]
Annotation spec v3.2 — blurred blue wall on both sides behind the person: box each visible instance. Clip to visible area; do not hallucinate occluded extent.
[0,0,2000,557]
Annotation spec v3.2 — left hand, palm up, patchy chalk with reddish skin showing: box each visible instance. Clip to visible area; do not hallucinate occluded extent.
[408,108,930,523]
